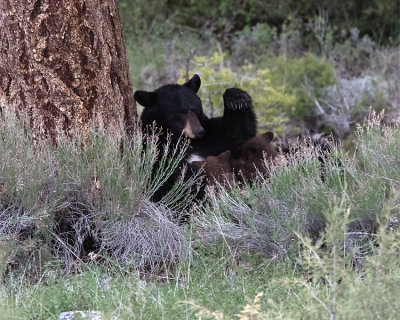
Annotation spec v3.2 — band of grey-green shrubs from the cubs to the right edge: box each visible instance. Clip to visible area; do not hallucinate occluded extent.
[198,113,400,267]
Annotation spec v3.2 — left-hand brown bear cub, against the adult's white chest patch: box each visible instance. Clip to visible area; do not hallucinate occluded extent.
[191,150,234,186]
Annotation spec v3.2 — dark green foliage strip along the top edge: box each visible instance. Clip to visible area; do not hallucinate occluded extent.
[120,0,400,45]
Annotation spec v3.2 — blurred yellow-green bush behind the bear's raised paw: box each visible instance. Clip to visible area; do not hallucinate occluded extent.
[180,52,335,134]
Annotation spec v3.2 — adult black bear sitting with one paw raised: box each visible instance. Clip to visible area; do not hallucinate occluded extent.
[135,75,256,201]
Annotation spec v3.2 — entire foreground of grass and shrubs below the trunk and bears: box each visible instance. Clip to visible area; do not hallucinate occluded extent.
[0,109,400,319]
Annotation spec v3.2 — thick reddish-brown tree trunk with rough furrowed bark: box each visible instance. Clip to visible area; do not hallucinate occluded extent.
[0,0,137,138]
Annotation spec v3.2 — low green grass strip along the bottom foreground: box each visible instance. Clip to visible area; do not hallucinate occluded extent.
[0,222,400,319]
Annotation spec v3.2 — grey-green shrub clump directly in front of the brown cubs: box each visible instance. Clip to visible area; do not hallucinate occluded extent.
[194,141,340,259]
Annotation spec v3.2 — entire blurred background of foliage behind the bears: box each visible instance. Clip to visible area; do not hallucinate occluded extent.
[120,0,400,138]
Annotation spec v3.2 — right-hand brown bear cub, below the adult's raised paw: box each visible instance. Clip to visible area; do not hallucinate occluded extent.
[232,131,278,182]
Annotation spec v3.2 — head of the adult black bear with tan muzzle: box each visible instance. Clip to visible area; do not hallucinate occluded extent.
[135,74,204,139]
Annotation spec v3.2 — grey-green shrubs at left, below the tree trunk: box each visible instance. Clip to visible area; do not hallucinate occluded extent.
[0,112,194,276]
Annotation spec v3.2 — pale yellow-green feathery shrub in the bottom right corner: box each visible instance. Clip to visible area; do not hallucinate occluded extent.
[285,190,400,319]
